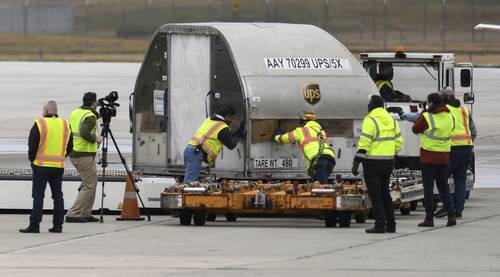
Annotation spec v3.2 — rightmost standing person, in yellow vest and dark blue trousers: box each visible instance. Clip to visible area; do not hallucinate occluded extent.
[435,87,477,218]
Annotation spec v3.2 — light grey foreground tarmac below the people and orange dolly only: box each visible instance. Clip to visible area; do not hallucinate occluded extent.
[0,188,500,277]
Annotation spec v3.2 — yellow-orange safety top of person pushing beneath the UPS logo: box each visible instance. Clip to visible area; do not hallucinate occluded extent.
[274,121,335,172]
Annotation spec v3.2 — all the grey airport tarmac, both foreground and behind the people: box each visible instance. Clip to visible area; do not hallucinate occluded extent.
[0,62,500,277]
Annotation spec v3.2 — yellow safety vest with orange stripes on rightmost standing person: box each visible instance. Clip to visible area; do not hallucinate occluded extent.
[446,105,474,146]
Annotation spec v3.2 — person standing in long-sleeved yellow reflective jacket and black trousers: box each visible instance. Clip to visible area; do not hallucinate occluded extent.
[351,95,403,233]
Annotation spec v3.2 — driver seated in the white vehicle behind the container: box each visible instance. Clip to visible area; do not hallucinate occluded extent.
[374,62,411,102]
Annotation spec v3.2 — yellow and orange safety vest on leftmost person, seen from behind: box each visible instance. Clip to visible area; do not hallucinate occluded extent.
[33,117,71,168]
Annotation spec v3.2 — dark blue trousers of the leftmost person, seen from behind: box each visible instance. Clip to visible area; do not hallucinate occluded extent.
[30,166,64,227]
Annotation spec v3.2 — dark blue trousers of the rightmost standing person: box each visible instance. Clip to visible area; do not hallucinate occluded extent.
[448,147,472,213]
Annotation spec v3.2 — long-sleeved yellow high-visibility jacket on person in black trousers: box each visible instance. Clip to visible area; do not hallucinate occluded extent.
[356,108,403,160]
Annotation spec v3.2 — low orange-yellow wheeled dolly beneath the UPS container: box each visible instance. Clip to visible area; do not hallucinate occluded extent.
[161,181,371,227]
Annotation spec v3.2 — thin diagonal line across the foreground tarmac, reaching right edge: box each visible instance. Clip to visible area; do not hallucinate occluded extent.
[214,211,500,270]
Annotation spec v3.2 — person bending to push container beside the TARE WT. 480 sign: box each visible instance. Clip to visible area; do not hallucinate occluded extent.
[274,112,335,184]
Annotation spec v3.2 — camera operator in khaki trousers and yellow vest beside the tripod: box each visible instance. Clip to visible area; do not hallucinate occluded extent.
[66,92,102,223]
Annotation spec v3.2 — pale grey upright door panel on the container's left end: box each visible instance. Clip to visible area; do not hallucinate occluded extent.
[167,34,210,168]
